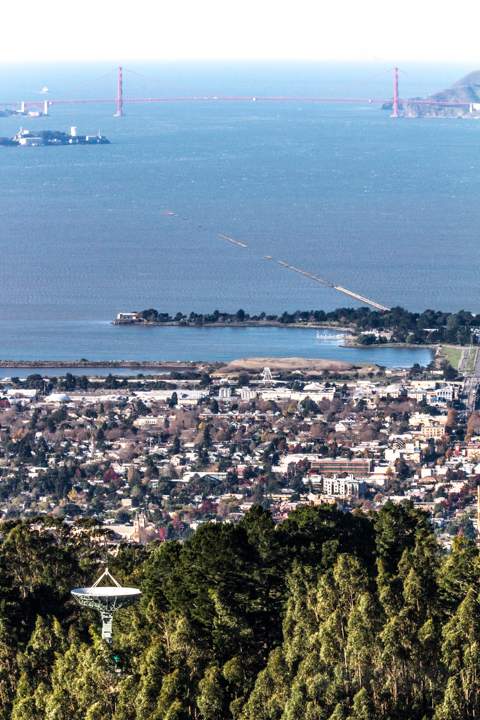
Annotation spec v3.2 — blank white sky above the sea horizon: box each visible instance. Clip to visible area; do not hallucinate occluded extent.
[0,0,480,66]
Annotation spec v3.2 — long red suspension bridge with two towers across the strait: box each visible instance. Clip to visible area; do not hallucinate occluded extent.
[0,65,470,118]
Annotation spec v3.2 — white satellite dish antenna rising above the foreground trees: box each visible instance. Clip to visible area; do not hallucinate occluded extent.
[70,568,142,643]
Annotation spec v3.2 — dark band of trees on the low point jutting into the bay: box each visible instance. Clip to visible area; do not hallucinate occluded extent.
[136,307,480,345]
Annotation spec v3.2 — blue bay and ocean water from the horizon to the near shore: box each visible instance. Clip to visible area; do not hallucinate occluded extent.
[0,63,472,366]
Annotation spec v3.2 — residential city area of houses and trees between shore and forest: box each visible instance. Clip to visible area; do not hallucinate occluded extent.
[0,366,480,545]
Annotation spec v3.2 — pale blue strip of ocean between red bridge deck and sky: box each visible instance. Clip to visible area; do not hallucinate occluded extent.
[0,59,475,102]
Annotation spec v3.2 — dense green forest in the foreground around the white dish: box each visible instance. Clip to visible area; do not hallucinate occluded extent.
[0,503,480,720]
